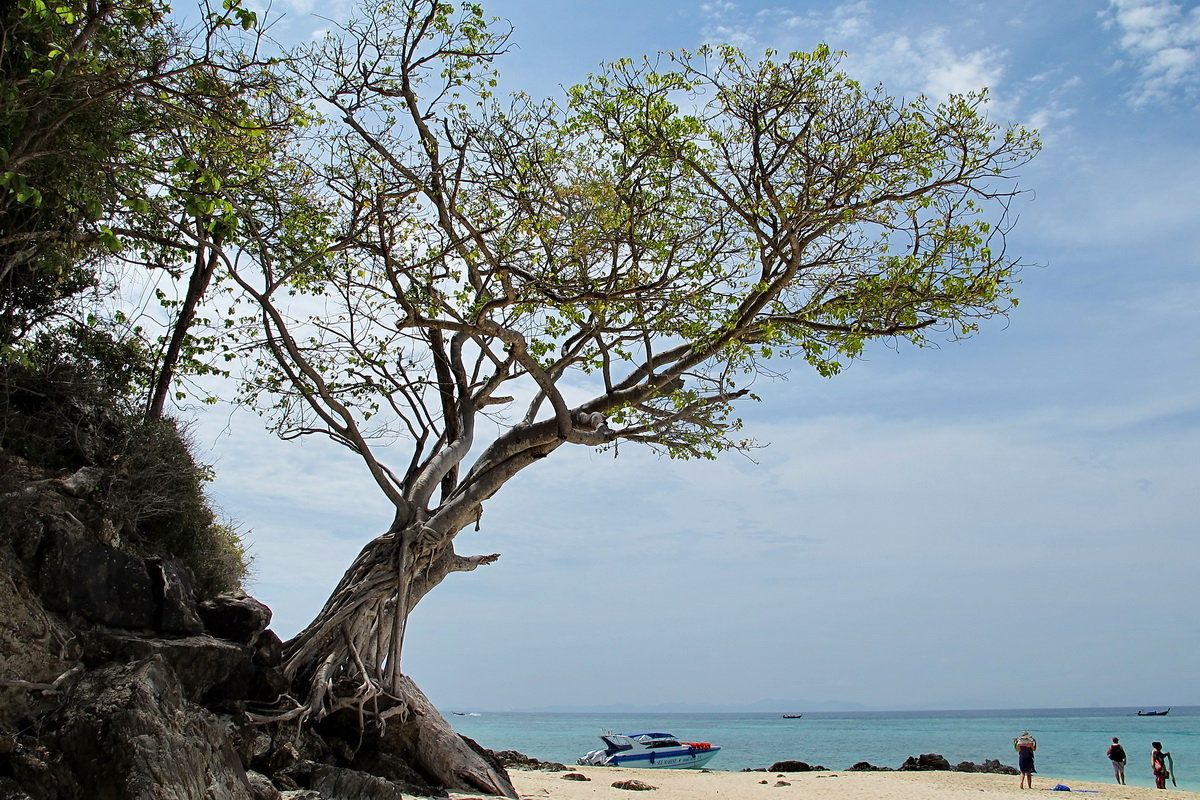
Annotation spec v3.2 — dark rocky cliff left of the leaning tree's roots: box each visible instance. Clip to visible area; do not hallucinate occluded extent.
[0,451,496,800]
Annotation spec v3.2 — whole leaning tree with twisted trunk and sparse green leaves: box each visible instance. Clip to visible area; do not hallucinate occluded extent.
[226,0,1038,794]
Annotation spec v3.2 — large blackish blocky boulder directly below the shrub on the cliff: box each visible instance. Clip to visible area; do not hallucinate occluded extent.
[37,530,204,633]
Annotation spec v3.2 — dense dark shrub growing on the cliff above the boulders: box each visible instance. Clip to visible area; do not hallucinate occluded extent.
[0,330,248,596]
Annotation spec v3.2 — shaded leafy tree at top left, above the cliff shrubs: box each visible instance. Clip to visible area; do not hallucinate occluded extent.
[0,0,288,419]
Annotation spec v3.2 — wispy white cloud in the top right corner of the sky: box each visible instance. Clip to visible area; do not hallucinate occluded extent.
[1104,0,1200,104]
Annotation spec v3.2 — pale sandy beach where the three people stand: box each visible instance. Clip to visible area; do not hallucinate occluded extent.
[477,766,1200,800]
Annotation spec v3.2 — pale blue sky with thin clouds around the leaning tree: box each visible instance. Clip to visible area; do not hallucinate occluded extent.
[193,0,1200,711]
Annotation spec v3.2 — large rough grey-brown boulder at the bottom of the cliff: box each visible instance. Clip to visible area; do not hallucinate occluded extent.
[54,656,252,800]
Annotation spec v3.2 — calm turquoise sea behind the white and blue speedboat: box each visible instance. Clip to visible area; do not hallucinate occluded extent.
[446,706,1200,792]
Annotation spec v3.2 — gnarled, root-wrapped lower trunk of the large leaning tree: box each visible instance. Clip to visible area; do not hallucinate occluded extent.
[283,524,517,798]
